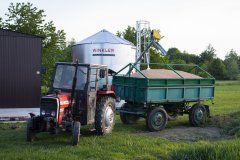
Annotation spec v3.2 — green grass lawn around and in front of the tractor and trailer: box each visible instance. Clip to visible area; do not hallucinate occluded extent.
[0,81,240,160]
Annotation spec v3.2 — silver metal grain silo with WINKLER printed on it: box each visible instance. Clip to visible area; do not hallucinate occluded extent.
[73,29,136,82]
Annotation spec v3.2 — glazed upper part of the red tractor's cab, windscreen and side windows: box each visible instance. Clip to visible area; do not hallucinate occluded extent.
[51,62,108,92]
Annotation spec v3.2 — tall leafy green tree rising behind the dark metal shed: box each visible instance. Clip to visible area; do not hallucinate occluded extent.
[2,3,66,85]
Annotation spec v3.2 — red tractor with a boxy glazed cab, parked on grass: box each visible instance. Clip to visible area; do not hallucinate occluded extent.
[26,62,115,145]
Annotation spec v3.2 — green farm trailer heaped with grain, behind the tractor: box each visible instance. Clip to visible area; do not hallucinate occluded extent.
[113,63,215,131]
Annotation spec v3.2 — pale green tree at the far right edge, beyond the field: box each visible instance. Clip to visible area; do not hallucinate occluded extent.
[224,49,239,80]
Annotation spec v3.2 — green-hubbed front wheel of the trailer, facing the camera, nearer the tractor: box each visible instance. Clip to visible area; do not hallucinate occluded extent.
[146,107,168,132]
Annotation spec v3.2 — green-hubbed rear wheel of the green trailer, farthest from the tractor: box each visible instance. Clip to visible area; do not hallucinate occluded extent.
[189,104,207,127]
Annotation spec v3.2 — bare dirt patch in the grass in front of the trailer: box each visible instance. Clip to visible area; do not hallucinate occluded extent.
[140,126,229,141]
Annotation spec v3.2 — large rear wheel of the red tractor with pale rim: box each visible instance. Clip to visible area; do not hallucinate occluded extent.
[95,97,115,135]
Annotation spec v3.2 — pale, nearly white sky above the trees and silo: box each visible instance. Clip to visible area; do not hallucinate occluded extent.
[0,0,240,59]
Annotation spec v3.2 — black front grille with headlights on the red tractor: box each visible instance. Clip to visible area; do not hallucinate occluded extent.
[40,97,59,117]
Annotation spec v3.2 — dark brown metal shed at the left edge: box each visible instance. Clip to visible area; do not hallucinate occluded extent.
[0,29,42,108]
